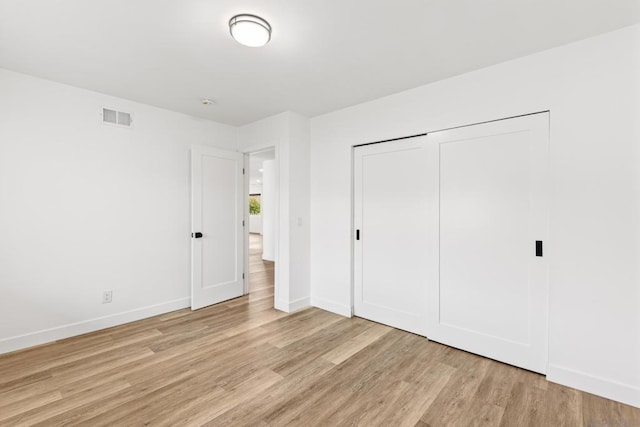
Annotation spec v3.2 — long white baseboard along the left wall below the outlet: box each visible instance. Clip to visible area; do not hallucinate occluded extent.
[0,297,191,354]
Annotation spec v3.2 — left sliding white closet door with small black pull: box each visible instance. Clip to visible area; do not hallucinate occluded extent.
[353,137,430,335]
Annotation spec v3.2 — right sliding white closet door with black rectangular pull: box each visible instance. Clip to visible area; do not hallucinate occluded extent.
[425,113,549,373]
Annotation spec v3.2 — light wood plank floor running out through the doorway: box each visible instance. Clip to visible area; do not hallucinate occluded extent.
[0,236,640,427]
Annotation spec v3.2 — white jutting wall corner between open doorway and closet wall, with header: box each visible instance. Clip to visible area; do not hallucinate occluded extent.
[238,112,310,312]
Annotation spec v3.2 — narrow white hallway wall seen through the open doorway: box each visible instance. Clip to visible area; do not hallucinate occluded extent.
[262,160,278,261]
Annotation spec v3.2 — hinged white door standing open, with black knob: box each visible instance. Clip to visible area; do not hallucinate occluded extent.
[191,147,244,310]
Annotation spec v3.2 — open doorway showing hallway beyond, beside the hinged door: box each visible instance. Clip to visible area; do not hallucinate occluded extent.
[248,148,277,306]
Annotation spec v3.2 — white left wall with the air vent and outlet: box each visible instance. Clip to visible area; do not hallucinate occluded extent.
[0,70,236,352]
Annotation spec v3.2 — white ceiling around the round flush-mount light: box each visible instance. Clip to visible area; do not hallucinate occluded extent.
[0,0,640,125]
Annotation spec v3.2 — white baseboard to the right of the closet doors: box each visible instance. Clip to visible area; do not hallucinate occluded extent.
[547,364,640,408]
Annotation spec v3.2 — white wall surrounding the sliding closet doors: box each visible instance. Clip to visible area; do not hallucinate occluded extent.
[311,26,640,406]
